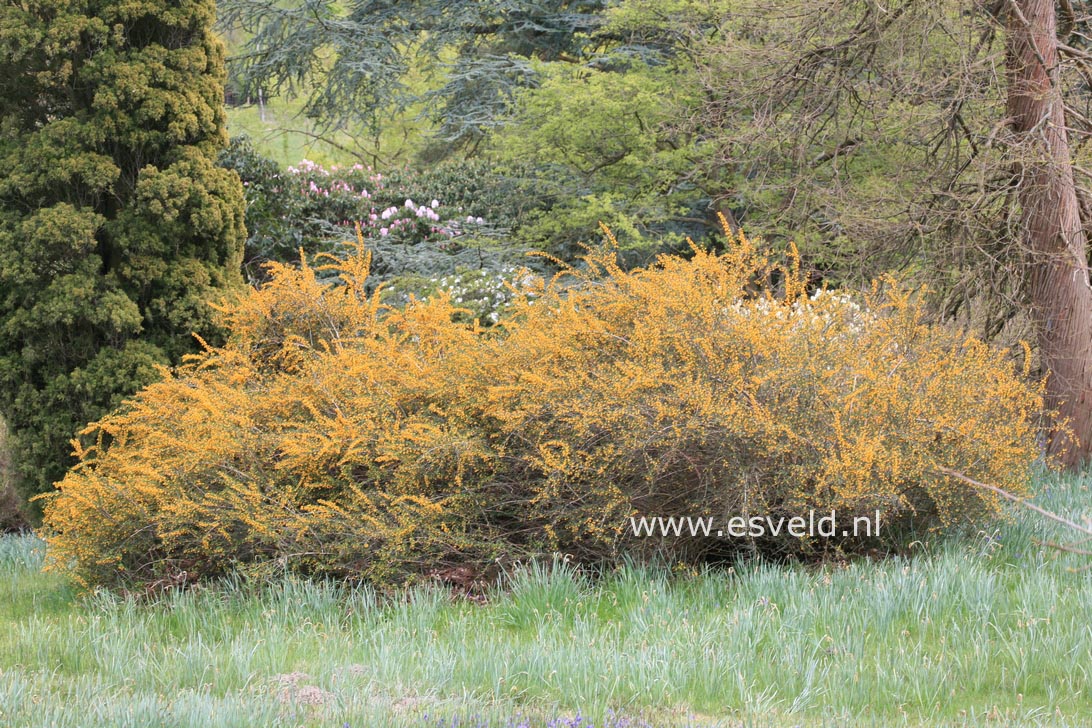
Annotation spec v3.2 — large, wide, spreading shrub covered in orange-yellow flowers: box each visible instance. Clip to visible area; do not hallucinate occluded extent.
[38,224,1042,584]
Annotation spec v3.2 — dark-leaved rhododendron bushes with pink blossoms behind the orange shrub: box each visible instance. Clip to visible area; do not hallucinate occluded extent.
[221,138,541,281]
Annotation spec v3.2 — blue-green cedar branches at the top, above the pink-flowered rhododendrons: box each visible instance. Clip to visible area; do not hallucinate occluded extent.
[221,0,607,145]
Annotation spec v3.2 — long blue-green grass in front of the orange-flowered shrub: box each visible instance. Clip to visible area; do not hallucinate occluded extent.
[0,469,1092,728]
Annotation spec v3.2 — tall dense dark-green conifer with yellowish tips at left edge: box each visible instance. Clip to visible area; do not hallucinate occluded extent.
[0,0,245,504]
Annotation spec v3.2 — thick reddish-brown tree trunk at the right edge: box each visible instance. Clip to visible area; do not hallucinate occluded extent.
[1007,0,1092,467]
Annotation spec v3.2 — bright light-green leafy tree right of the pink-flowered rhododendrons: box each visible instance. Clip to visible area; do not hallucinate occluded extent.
[488,52,715,264]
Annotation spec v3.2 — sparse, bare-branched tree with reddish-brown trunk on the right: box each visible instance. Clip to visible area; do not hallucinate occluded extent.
[688,0,1092,466]
